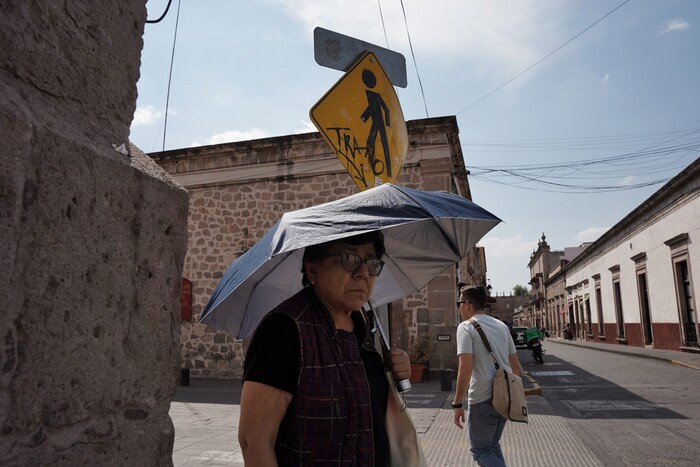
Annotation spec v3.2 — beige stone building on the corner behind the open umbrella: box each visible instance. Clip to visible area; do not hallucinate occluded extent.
[150,117,486,377]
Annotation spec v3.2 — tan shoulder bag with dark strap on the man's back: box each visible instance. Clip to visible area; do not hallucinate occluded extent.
[469,318,527,423]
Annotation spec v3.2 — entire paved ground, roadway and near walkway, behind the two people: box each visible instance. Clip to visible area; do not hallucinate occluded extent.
[170,340,700,467]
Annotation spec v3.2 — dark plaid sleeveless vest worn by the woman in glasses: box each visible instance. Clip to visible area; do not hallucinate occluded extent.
[275,288,374,466]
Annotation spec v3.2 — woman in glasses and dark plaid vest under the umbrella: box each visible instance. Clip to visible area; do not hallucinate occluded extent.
[238,231,410,466]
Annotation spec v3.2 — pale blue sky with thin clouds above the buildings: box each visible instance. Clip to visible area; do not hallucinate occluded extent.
[130,0,700,295]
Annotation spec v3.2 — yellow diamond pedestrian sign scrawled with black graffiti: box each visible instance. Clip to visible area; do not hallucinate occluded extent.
[309,52,408,190]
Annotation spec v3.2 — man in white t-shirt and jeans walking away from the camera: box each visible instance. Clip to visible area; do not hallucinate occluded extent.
[452,286,522,467]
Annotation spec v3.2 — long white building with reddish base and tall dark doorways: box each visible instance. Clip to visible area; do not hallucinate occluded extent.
[563,159,700,351]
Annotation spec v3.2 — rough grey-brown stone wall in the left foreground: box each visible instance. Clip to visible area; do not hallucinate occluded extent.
[0,0,187,466]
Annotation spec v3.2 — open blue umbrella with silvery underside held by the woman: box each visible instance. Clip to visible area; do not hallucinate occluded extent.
[200,184,500,339]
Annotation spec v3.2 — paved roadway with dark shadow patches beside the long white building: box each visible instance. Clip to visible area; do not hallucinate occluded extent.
[523,341,700,466]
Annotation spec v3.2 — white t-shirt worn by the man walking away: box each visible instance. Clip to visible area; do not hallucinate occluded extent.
[457,313,516,405]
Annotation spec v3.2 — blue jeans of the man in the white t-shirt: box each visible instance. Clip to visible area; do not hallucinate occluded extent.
[467,401,506,467]
